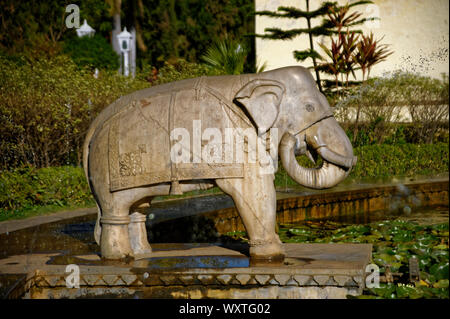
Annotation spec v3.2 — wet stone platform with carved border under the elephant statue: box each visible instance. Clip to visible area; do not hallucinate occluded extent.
[0,244,372,299]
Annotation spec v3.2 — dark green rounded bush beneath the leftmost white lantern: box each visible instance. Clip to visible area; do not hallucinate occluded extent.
[64,35,119,70]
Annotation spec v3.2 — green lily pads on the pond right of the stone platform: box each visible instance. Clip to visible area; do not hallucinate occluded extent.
[278,220,449,299]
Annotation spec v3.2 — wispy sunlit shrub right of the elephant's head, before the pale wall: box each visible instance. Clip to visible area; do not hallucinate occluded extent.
[335,72,449,145]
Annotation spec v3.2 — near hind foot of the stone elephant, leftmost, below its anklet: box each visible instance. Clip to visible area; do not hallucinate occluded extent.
[100,216,134,260]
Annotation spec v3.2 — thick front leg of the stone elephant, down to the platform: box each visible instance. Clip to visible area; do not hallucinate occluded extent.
[216,165,284,259]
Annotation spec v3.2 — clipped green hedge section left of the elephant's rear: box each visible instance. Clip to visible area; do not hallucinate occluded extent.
[0,166,93,215]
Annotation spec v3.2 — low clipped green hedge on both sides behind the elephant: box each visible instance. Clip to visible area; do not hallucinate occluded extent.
[0,143,449,218]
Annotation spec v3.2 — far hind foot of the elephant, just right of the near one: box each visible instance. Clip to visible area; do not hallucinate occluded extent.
[128,212,152,259]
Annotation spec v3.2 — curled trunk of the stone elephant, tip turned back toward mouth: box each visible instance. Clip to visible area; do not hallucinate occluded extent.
[280,118,356,189]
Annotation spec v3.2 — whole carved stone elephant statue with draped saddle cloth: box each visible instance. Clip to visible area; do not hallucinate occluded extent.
[83,66,356,259]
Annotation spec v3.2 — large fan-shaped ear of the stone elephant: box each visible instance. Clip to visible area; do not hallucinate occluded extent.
[234,79,286,134]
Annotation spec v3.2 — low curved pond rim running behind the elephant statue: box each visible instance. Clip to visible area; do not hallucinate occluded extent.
[0,175,449,234]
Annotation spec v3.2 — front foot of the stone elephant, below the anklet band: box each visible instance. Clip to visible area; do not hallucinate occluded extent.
[249,238,285,264]
